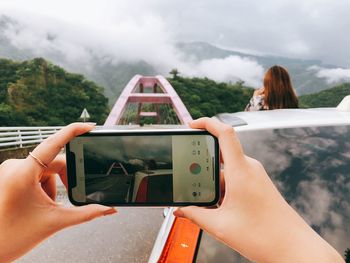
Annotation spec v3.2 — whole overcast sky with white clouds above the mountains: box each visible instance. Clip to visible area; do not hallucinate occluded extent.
[0,0,350,84]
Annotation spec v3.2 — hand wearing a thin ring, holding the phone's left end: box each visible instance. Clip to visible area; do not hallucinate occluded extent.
[0,123,116,262]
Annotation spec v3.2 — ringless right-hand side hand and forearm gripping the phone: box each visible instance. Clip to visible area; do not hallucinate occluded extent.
[174,118,343,262]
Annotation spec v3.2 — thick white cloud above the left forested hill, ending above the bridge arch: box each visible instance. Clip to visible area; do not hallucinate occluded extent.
[0,10,178,67]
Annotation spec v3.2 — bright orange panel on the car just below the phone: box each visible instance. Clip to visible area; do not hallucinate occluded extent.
[158,217,200,263]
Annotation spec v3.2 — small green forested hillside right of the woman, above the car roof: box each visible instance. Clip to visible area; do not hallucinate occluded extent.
[299,83,350,108]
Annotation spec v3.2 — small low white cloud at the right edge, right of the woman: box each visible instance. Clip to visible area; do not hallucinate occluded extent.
[309,66,350,84]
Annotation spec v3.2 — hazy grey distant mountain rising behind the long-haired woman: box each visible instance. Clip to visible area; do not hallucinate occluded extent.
[177,42,350,95]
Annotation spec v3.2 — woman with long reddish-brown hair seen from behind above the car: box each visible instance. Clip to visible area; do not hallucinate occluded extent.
[245,65,298,111]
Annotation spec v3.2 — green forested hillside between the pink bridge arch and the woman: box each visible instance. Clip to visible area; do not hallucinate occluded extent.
[169,76,253,118]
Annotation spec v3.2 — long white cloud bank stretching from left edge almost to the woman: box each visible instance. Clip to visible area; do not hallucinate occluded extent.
[0,8,264,86]
